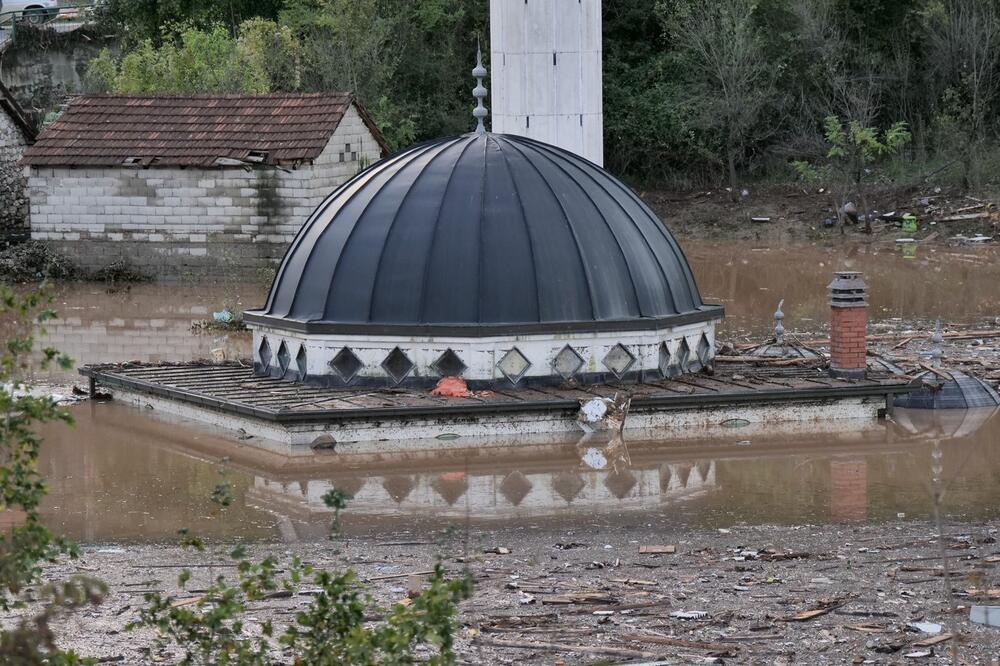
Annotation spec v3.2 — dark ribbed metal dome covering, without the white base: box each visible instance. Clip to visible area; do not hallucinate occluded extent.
[247,134,722,335]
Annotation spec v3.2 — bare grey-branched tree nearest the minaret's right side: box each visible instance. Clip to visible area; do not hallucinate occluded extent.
[661,0,776,199]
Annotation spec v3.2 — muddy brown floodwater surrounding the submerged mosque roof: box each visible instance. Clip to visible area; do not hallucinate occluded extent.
[27,242,1000,543]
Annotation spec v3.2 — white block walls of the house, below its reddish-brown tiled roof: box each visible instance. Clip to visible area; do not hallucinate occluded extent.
[29,107,380,279]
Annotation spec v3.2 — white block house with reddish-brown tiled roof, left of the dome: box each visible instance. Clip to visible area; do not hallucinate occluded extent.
[22,93,386,277]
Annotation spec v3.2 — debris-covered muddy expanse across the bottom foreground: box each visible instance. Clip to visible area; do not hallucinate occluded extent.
[7,517,1000,664]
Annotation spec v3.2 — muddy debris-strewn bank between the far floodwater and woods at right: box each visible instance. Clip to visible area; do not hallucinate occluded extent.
[639,185,1000,242]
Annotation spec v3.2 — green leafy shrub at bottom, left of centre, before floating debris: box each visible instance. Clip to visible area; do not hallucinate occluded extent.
[128,479,471,666]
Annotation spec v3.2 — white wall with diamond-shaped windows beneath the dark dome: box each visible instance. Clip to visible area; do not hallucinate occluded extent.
[248,319,719,389]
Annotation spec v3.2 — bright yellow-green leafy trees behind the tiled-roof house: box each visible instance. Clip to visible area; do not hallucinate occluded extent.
[86,19,300,94]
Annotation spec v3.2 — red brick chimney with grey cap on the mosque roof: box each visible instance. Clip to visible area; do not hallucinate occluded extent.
[829,271,868,379]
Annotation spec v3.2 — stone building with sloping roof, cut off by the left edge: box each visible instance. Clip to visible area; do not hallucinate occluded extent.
[0,78,36,245]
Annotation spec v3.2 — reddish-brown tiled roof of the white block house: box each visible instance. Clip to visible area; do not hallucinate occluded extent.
[22,92,386,167]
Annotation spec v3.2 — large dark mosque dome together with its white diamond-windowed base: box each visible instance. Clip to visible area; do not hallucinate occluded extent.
[244,131,723,386]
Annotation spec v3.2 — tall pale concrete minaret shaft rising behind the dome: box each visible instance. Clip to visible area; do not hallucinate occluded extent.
[490,0,604,165]
